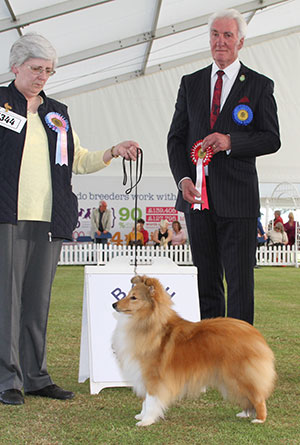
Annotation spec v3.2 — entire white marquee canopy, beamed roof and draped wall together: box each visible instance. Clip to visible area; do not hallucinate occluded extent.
[0,0,300,199]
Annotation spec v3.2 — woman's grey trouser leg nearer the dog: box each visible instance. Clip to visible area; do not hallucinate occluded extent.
[20,223,62,391]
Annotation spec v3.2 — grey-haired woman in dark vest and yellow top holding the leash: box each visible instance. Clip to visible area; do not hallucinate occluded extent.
[0,34,138,405]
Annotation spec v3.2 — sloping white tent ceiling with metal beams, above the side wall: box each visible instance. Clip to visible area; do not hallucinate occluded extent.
[0,0,300,97]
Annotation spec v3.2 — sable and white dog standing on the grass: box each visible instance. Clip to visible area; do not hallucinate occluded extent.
[113,276,276,426]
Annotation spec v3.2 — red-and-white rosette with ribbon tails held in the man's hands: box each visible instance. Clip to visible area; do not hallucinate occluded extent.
[191,140,213,210]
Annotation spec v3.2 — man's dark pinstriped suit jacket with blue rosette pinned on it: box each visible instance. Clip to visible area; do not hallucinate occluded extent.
[168,64,280,217]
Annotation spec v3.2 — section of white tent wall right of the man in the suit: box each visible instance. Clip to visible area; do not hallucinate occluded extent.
[242,33,300,183]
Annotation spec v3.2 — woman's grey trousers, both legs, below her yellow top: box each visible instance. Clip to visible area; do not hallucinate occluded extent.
[0,221,62,391]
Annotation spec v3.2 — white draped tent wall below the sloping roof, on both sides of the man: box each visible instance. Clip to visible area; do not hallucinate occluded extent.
[62,27,300,190]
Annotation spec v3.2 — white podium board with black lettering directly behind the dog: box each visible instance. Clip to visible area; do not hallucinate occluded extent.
[78,257,200,394]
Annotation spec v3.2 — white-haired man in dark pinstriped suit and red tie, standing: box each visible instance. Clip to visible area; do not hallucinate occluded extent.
[168,9,280,323]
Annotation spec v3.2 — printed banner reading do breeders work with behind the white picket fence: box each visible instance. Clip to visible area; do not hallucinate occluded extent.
[73,175,187,245]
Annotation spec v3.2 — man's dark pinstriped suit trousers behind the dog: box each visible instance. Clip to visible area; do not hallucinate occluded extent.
[185,181,257,324]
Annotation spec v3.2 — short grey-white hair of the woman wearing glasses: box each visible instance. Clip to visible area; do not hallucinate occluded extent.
[9,33,57,69]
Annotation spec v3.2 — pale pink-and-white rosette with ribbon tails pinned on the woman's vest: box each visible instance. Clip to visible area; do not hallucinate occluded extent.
[45,112,69,165]
